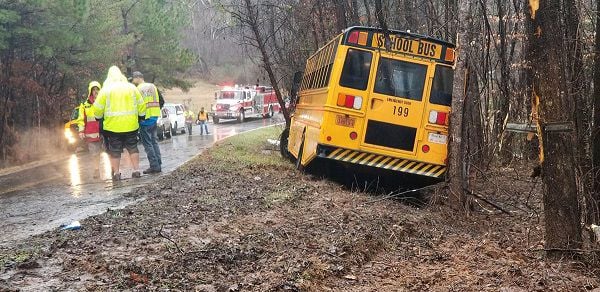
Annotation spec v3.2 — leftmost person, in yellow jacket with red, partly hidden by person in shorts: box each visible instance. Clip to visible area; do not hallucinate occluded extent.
[77,81,102,178]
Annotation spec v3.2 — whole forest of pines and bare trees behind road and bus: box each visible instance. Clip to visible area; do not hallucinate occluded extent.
[0,0,600,256]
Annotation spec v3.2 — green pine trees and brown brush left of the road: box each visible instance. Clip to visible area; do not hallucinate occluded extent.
[0,0,196,166]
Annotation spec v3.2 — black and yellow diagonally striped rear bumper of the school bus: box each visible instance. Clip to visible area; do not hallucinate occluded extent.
[321,148,446,178]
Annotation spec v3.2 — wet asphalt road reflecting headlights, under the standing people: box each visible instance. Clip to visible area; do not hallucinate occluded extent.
[0,115,282,246]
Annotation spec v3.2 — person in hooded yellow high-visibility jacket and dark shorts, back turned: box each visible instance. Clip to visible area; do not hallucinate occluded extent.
[93,66,146,181]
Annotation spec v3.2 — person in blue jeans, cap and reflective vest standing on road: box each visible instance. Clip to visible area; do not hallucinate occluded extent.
[132,71,162,174]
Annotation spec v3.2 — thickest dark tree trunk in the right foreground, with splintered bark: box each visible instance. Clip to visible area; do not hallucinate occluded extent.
[528,0,582,257]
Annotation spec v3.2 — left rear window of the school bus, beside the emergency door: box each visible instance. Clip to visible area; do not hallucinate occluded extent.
[340,49,373,90]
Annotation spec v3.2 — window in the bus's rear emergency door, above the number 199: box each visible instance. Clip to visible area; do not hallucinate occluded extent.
[375,58,427,101]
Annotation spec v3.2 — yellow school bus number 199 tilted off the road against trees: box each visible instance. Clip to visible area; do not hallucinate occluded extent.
[287,27,455,178]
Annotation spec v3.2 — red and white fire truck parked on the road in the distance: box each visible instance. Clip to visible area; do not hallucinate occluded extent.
[211,85,279,124]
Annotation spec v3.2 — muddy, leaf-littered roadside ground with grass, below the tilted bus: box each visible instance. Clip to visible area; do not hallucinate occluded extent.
[0,128,599,291]
